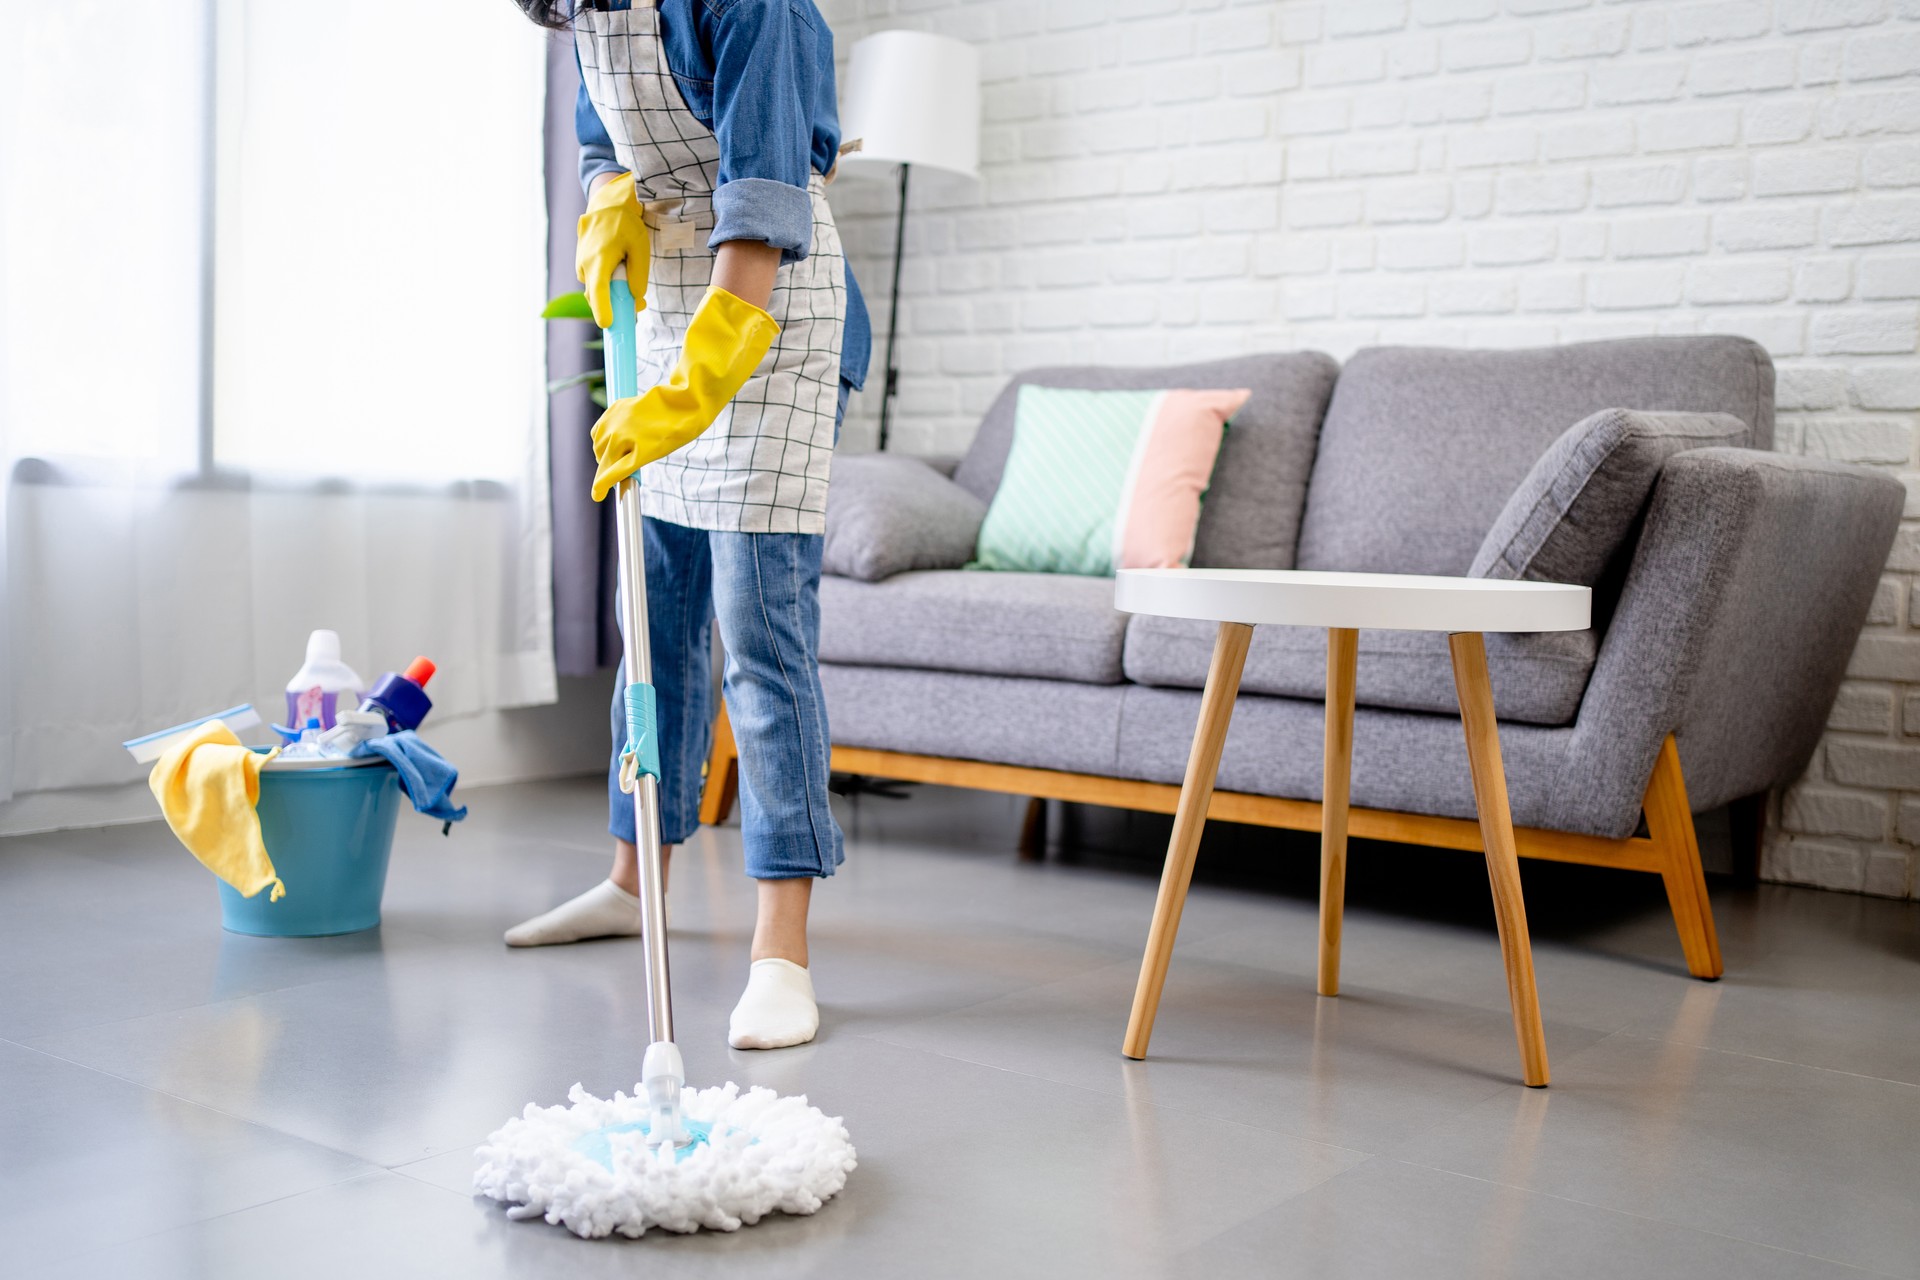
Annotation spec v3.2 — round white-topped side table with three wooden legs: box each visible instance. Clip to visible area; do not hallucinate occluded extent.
[1114,568,1594,1088]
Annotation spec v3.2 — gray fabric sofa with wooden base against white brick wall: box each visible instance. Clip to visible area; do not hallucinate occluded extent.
[721,338,1905,971]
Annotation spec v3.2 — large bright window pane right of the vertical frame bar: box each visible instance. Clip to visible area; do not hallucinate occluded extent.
[213,0,545,482]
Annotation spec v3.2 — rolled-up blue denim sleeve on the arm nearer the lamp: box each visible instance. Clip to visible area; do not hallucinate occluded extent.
[707,0,820,263]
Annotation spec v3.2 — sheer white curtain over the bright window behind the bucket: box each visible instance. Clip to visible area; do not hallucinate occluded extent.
[0,0,555,798]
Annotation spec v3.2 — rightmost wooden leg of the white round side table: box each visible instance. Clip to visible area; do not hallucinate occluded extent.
[1448,631,1548,1088]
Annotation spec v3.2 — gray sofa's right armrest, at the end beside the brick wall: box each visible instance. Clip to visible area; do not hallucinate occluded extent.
[1561,449,1907,835]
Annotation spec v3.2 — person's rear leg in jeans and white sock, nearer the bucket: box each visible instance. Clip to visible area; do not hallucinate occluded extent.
[507,520,712,946]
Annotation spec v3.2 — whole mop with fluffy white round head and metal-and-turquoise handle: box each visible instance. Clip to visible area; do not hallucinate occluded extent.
[474,271,854,1238]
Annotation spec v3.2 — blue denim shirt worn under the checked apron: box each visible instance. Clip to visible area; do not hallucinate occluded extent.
[574,0,874,388]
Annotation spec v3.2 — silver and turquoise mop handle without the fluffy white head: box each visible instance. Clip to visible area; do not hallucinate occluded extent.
[605,267,674,1044]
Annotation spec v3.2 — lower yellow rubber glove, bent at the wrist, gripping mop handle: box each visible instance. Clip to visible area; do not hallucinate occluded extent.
[593,286,780,503]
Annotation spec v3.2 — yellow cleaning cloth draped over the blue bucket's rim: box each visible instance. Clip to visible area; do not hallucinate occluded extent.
[146,720,286,902]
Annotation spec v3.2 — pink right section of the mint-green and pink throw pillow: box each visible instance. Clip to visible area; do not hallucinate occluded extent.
[1114,388,1252,568]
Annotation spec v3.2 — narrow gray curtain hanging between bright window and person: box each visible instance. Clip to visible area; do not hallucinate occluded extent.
[547,36,620,676]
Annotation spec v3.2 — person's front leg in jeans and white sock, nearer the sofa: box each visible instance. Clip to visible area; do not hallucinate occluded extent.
[708,532,845,1048]
